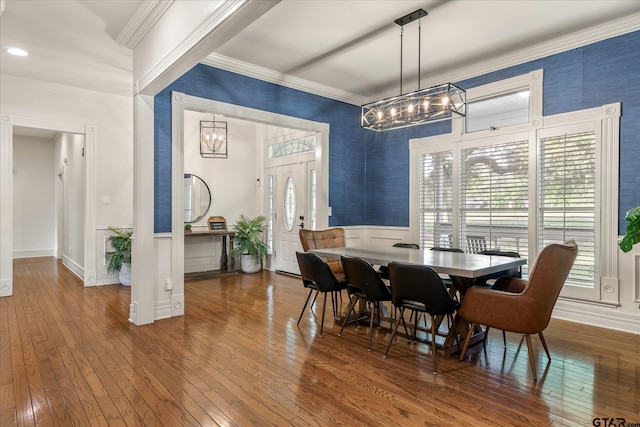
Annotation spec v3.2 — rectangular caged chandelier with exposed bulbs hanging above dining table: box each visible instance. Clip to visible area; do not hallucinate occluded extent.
[360,9,466,132]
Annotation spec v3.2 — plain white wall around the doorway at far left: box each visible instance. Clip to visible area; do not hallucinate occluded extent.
[0,75,134,284]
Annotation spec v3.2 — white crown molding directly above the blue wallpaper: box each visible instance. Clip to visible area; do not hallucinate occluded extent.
[200,13,640,105]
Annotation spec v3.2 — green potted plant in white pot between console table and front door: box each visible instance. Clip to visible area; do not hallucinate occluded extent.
[232,215,269,273]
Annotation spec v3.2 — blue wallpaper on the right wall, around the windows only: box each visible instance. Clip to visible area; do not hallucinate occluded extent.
[365,31,640,234]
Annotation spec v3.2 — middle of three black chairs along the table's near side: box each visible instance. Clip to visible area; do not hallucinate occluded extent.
[338,257,391,351]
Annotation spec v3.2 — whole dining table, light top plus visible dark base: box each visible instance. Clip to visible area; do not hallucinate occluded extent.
[309,246,527,357]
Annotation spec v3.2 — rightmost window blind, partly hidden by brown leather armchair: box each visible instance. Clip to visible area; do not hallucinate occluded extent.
[538,131,596,289]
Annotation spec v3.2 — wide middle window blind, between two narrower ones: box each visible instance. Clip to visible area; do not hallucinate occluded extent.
[459,139,529,257]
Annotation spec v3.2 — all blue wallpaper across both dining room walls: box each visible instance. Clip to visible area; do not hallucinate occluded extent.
[155,31,640,232]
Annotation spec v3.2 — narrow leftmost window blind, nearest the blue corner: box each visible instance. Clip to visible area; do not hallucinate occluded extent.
[419,151,454,248]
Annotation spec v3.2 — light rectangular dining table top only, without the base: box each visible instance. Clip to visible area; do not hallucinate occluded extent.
[309,246,527,279]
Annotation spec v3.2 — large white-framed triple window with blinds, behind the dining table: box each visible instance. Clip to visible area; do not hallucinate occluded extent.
[410,71,621,306]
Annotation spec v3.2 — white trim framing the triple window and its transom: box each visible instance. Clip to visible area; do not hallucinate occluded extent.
[409,70,621,307]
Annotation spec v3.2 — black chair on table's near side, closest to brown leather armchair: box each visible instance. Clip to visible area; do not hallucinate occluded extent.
[383,262,460,374]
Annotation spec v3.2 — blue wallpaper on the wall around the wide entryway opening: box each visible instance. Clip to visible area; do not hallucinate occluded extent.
[154,65,365,233]
